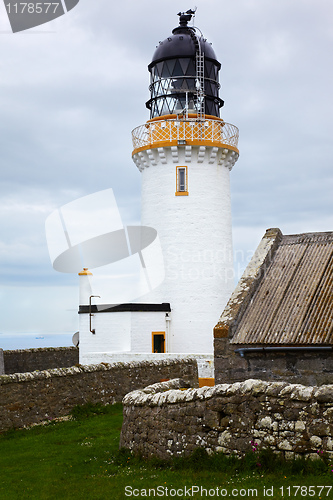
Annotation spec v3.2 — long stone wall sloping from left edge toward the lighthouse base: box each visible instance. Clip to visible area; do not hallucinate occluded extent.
[0,359,198,430]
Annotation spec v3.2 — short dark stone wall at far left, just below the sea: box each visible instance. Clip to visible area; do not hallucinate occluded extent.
[3,347,79,374]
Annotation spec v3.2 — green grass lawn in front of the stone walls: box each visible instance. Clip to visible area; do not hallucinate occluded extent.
[0,405,333,500]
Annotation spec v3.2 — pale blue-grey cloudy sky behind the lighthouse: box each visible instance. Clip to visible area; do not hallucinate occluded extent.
[0,0,333,347]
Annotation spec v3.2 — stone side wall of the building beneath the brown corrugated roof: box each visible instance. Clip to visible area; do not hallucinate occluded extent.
[214,338,333,385]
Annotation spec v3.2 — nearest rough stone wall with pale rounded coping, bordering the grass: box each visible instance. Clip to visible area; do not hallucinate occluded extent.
[120,380,333,459]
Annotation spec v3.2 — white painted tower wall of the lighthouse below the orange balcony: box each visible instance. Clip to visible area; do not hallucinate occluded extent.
[133,146,238,353]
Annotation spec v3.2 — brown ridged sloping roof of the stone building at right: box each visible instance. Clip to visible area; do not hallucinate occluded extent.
[214,229,333,346]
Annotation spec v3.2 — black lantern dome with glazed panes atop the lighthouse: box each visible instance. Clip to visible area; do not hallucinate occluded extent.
[146,10,223,118]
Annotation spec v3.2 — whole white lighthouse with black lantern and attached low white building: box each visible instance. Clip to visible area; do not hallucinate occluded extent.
[79,11,239,382]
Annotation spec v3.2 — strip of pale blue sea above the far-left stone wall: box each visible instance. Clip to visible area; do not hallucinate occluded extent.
[0,332,74,351]
